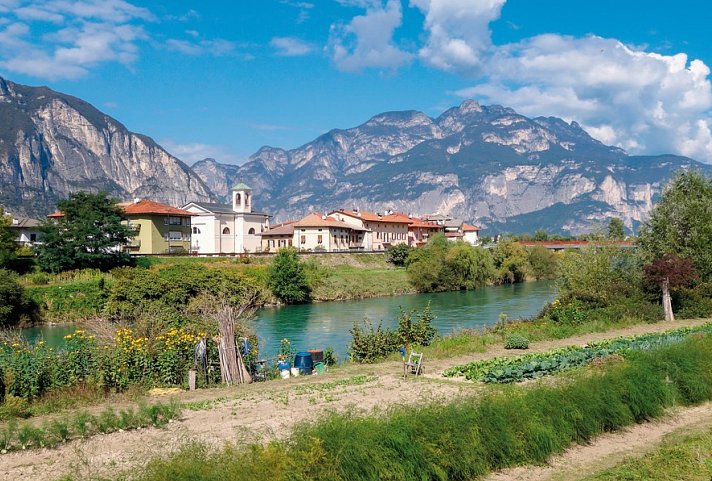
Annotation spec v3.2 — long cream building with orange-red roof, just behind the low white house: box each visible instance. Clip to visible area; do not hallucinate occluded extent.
[328,209,413,251]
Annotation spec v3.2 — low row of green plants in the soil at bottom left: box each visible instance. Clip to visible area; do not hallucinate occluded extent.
[0,402,181,454]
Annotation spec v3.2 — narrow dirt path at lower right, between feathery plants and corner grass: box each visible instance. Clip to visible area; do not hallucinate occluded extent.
[485,403,712,481]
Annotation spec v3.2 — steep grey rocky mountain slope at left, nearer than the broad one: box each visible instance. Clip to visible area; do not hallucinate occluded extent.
[0,78,215,216]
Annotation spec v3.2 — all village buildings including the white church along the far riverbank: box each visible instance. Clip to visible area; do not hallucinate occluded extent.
[4,183,480,255]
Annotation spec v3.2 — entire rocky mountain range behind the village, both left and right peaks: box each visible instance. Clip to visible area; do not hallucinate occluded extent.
[0,78,712,234]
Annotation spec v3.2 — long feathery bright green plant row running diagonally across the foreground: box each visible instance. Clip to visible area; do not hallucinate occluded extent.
[76,338,712,481]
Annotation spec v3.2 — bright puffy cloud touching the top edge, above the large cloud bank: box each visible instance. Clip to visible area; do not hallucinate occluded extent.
[411,0,506,70]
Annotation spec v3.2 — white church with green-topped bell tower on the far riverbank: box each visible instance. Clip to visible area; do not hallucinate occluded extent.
[183,183,271,254]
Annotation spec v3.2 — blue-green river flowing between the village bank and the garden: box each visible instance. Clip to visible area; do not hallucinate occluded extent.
[23,282,555,359]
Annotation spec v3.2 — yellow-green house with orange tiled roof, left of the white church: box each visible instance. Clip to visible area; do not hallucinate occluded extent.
[119,199,193,255]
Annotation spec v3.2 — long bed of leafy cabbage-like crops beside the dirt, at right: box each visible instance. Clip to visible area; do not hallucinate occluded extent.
[443,323,712,383]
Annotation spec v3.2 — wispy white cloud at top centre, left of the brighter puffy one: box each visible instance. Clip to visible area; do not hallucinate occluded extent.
[328,0,413,72]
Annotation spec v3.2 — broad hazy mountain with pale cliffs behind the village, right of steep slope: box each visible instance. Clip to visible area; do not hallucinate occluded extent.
[194,100,711,234]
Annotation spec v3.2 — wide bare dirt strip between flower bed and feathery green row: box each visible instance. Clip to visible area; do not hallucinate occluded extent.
[0,320,712,481]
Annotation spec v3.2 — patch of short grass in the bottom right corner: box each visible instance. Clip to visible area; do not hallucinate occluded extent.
[582,429,712,481]
